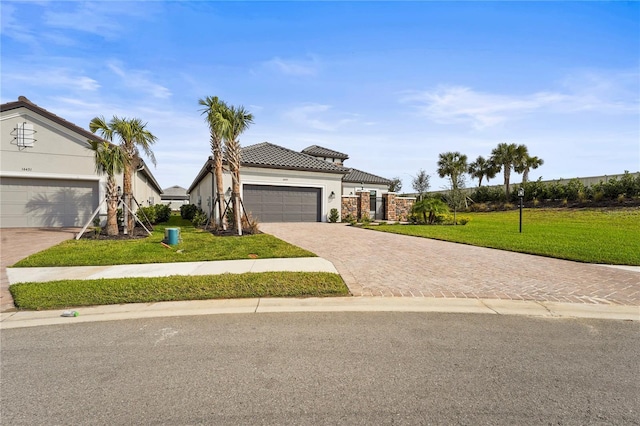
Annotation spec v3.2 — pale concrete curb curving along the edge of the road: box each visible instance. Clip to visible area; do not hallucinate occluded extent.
[0,297,640,330]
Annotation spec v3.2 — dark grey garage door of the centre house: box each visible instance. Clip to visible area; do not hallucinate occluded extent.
[242,185,322,223]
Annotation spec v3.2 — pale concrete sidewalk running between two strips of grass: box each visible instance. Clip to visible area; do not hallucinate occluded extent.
[7,257,338,285]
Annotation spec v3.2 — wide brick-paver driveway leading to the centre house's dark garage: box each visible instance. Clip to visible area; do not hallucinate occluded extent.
[260,223,640,305]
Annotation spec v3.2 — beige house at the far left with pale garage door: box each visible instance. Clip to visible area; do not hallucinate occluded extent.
[0,96,162,228]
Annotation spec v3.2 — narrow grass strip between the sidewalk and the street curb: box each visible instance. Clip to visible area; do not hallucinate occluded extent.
[9,272,349,310]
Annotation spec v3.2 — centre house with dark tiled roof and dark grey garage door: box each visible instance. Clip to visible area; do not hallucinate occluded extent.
[187,142,408,222]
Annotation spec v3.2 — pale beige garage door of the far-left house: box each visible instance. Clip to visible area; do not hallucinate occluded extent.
[0,178,98,228]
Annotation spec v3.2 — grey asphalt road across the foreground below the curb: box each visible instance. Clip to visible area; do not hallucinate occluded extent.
[0,313,640,425]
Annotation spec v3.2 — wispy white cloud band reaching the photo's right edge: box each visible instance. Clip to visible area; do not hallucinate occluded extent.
[401,73,639,129]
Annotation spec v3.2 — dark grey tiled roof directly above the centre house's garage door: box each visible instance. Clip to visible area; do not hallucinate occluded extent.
[241,142,348,174]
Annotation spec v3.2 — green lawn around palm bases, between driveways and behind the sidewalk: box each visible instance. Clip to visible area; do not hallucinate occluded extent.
[14,216,316,267]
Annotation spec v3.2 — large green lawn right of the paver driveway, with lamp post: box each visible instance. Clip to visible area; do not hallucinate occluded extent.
[369,208,640,266]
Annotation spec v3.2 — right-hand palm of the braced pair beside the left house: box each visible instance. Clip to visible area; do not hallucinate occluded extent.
[89,115,157,234]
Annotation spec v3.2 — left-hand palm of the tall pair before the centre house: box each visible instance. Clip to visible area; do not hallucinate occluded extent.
[198,96,228,227]
